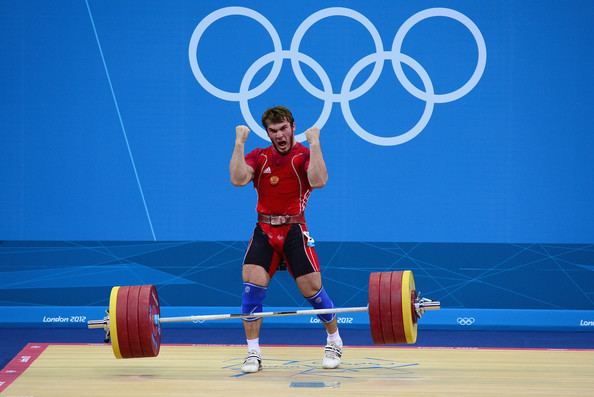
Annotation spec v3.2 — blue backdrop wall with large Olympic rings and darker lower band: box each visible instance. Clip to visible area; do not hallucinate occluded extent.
[0,0,594,329]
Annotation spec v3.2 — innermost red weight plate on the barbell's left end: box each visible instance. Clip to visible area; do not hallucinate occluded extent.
[138,285,161,357]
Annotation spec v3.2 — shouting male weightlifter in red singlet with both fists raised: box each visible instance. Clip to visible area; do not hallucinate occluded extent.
[229,106,342,373]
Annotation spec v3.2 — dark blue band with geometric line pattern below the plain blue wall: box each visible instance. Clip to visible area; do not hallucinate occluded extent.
[0,241,594,310]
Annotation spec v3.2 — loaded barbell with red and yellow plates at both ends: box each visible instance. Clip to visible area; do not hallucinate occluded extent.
[87,270,440,358]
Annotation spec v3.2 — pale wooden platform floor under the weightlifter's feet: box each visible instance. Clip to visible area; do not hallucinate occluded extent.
[2,345,594,397]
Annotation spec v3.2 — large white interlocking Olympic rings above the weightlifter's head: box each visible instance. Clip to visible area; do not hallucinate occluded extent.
[188,7,487,146]
